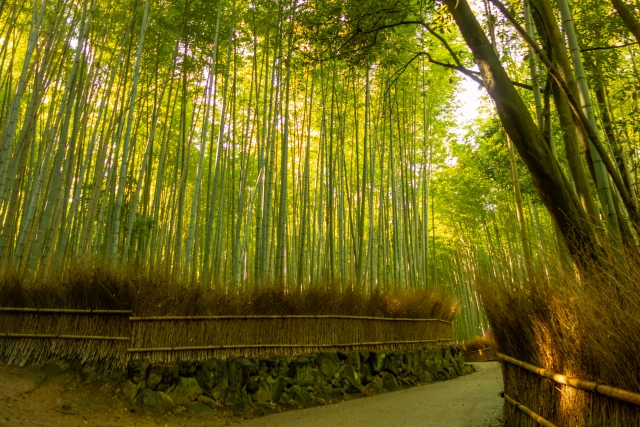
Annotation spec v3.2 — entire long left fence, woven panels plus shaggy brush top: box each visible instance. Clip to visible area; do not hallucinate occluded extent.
[0,270,459,370]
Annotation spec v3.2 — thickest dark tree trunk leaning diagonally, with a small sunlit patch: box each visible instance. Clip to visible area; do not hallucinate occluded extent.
[444,0,598,265]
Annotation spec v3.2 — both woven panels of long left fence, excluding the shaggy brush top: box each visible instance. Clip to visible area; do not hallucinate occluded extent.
[0,307,453,370]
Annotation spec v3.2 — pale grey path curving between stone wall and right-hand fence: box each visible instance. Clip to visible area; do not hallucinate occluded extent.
[234,362,503,427]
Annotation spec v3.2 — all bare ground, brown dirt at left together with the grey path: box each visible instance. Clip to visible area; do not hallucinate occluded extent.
[0,362,503,427]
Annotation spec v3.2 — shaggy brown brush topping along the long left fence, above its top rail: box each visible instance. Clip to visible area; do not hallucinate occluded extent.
[0,264,459,321]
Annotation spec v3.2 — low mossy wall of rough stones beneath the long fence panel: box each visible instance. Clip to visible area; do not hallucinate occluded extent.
[120,345,467,415]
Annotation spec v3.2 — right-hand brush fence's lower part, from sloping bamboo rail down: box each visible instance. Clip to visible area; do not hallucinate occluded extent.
[496,353,640,427]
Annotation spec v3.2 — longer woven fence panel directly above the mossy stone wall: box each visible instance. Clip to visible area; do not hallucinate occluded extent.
[129,315,453,363]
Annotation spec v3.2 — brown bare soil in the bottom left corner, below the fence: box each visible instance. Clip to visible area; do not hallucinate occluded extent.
[0,364,244,427]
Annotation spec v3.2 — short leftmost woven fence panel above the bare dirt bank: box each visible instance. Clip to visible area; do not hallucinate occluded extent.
[0,307,131,369]
